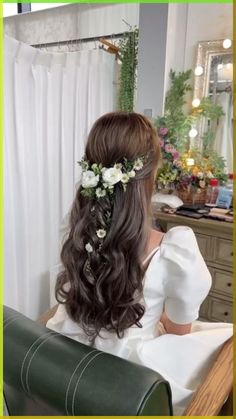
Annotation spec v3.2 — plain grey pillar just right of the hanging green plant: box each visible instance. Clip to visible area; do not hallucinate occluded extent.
[136,3,168,117]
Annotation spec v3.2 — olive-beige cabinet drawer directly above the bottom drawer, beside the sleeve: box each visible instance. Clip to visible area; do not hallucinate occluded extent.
[210,268,233,298]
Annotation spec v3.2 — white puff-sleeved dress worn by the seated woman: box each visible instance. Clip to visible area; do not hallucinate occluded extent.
[47,227,232,415]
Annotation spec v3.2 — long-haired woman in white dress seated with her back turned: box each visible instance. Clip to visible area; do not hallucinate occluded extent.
[47,113,232,415]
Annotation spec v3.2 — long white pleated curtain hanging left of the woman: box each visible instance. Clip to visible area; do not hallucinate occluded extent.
[4,37,116,318]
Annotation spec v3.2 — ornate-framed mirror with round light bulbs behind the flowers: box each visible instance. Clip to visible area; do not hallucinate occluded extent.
[194,39,233,173]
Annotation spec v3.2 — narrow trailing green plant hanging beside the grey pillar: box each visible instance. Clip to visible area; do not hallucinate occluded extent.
[118,28,139,112]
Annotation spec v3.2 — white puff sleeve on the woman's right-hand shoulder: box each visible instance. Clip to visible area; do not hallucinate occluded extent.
[161,226,211,324]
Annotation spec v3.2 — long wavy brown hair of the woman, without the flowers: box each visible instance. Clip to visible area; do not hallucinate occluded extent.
[56,112,160,341]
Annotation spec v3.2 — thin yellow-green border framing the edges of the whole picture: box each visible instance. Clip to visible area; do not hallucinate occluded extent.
[0,0,236,419]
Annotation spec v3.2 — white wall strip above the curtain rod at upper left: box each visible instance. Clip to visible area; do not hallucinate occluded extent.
[4,3,139,45]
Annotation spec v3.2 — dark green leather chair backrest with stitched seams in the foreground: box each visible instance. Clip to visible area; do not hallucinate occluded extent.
[3,307,172,416]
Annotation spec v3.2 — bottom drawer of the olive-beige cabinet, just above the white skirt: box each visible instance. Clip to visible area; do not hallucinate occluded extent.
[208,297,233,323]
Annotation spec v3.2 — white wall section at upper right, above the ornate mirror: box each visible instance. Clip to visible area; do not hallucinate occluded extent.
[164,3,233,107]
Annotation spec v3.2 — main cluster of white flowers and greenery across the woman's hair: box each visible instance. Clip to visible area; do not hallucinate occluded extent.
[78,157,144,199]
